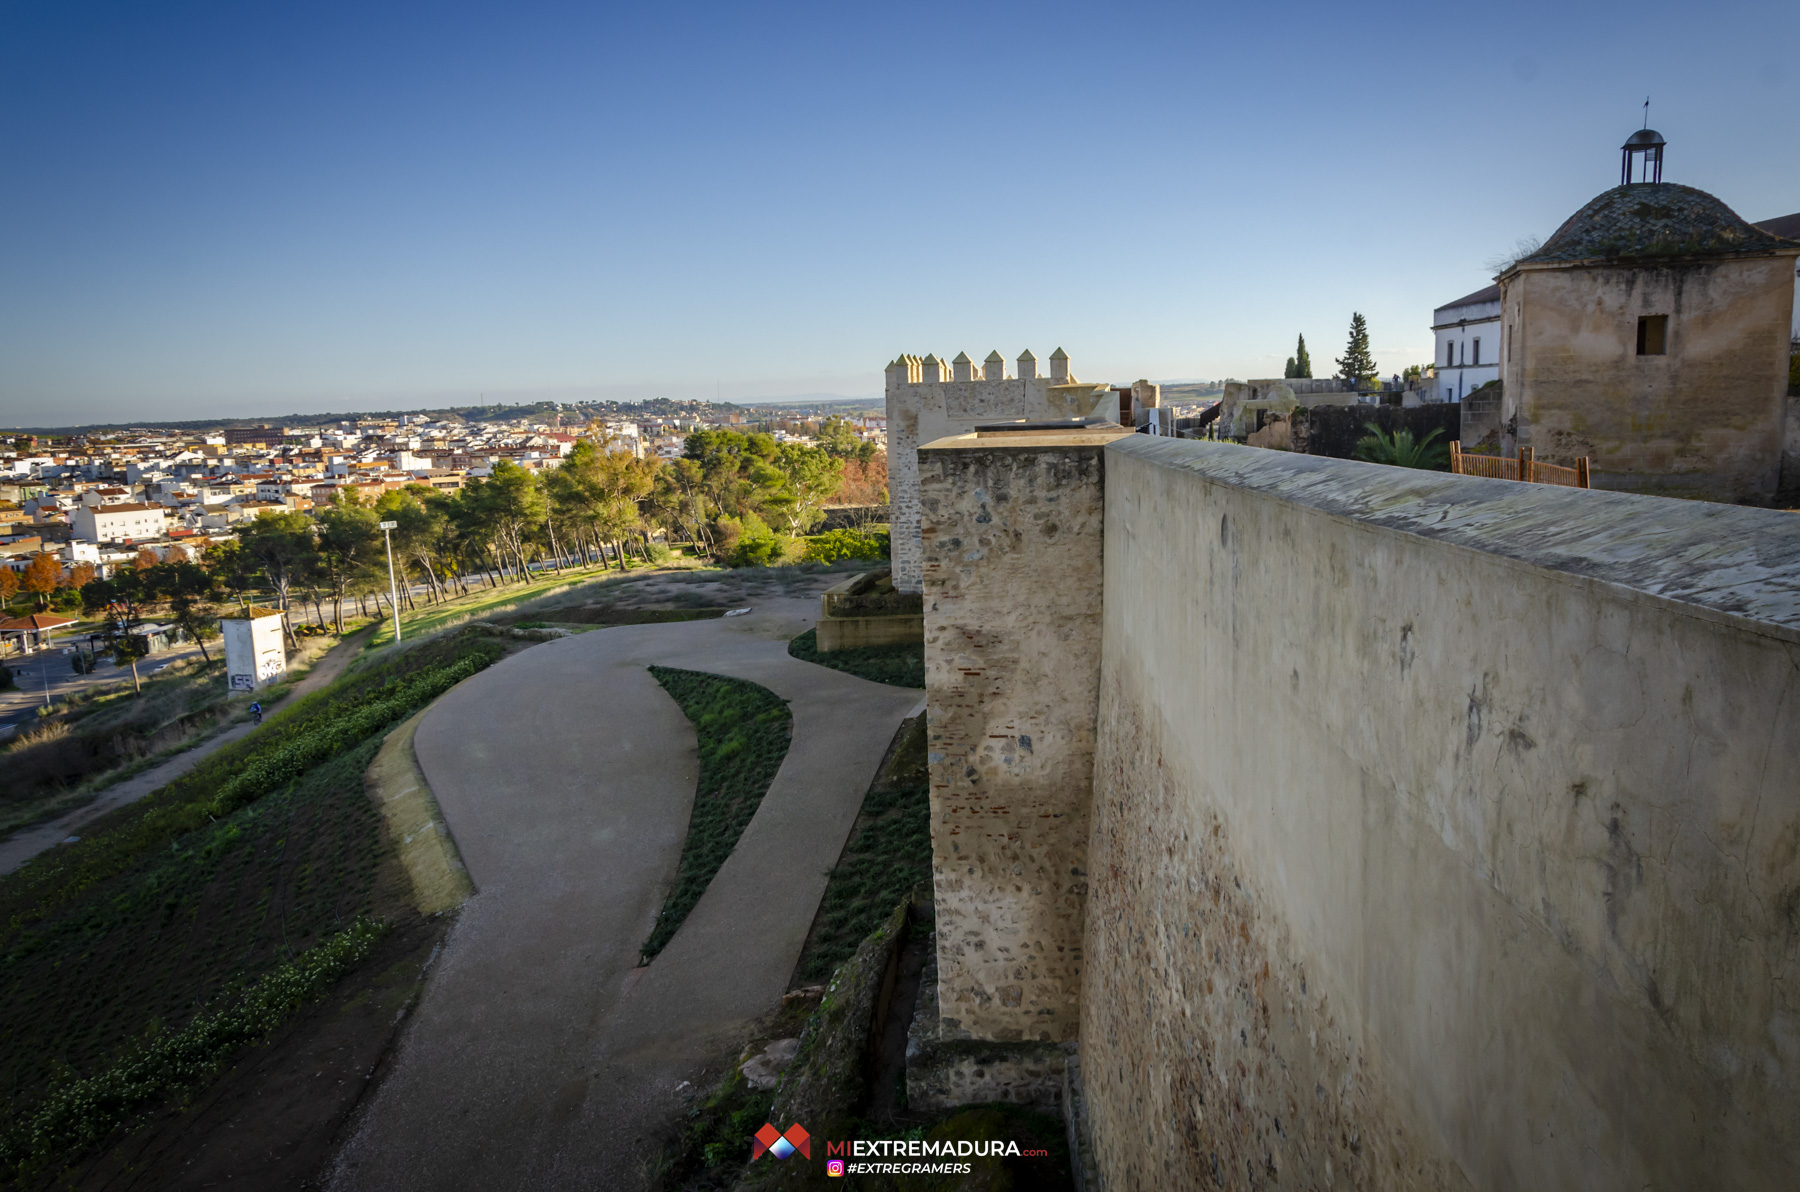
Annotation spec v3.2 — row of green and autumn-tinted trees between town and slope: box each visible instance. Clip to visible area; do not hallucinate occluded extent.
[10,418,887,661]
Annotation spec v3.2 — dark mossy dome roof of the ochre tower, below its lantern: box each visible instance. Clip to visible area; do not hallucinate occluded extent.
[1519,182,1793,265]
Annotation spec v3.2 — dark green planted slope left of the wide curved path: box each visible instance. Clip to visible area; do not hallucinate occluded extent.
[0,634,502,1181]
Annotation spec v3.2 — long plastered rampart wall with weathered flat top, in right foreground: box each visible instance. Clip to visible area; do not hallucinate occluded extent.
[1080,436,1800,1190]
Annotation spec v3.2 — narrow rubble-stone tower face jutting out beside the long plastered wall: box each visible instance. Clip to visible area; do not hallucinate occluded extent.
[918,434,1112,1043]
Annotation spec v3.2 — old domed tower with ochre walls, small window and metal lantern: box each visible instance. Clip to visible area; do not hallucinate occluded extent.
[1499,128,1800,504]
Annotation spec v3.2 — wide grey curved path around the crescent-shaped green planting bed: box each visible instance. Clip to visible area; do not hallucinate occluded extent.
[331,598,922,1192]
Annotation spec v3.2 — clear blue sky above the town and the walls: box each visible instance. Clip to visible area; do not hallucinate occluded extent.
[0,0,1800,425]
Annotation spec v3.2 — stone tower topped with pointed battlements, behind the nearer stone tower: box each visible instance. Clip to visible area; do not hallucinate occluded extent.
[887,348,1111,592]
